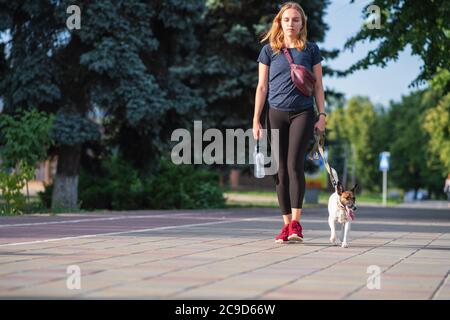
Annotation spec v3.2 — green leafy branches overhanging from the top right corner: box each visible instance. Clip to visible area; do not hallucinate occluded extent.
[344,0,450,90]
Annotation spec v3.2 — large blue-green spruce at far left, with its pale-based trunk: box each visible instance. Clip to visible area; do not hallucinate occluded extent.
[0,0,204,208]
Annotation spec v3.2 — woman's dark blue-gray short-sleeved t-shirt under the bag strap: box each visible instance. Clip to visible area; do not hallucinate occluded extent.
[257,41,323,111]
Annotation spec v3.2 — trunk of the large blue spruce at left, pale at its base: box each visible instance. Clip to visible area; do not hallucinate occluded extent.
[52,145,81,210]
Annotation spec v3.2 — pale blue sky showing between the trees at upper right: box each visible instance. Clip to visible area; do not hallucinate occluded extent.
[320,0,423,107]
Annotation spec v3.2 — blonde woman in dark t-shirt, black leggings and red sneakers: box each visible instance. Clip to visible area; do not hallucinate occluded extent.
[253,2,326,243]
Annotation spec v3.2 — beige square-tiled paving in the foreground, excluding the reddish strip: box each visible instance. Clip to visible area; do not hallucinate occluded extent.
[0,209,450,300]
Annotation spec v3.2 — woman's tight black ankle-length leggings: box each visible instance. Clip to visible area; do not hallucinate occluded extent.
[268,106,315,214]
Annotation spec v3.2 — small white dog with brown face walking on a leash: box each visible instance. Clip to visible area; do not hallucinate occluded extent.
[328,168,358,248]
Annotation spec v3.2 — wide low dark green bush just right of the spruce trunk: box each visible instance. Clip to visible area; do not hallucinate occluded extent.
[73,157,225,210]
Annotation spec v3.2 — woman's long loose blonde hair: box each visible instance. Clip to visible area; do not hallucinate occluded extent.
[261,2,307,54]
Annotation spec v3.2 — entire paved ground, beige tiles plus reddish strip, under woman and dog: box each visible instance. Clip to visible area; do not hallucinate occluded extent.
[0,206,450,299]
